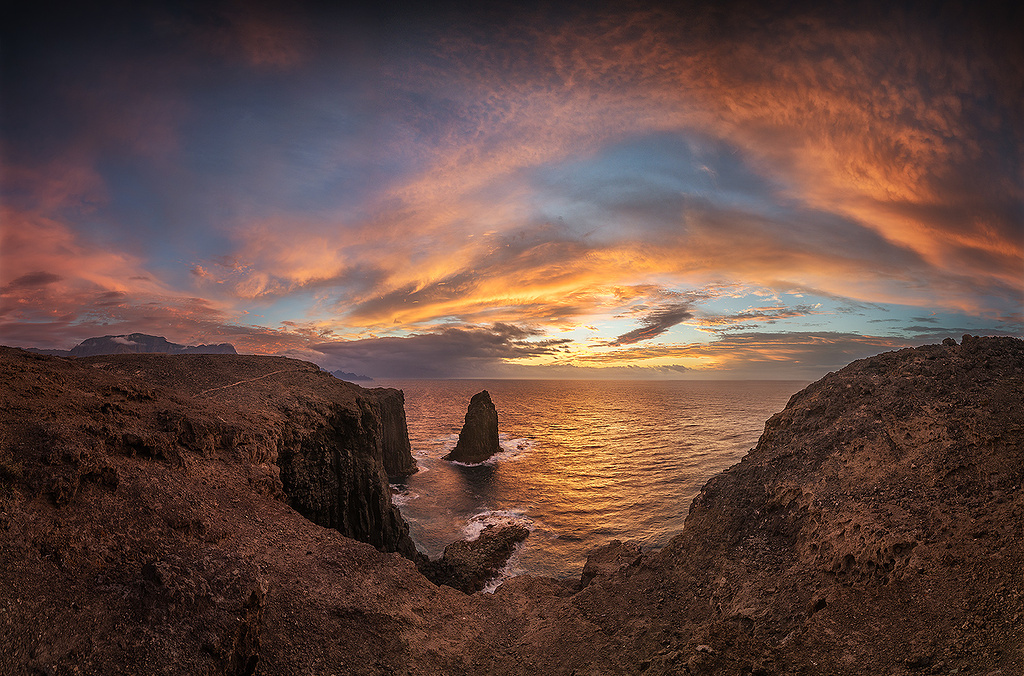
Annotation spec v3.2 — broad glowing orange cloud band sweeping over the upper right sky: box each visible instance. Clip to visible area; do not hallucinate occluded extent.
[362,2,1024,319]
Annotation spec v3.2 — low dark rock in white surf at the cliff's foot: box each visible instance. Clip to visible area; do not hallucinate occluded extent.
[419,523,529,594]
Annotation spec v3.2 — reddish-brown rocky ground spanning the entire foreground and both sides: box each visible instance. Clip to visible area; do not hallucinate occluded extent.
[0,337,1024,676]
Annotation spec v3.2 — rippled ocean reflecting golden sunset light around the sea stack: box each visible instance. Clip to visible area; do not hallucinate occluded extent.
[373,380,807,589]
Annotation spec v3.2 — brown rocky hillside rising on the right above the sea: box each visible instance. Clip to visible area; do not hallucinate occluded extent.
[575,336,1024,674]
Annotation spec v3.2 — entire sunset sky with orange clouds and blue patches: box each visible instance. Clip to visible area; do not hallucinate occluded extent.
[0,0,1024,379]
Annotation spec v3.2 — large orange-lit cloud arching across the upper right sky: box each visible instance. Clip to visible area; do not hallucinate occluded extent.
[378,0,1022,309]
